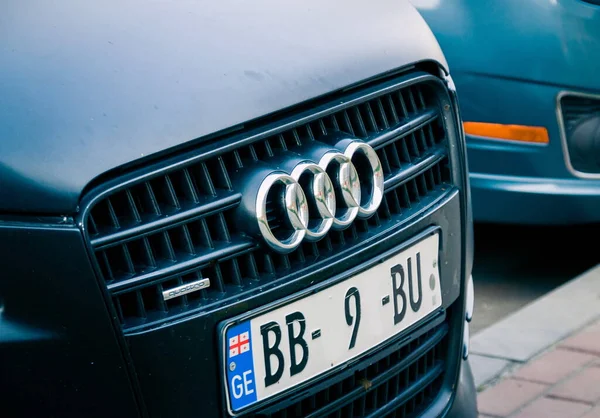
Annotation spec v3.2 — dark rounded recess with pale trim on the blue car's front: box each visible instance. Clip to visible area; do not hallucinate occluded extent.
[559,93,600,174]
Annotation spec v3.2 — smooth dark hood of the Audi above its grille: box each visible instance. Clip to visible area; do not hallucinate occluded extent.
[0,0,446,214]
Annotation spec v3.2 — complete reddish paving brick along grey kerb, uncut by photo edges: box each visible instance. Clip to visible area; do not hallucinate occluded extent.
[513,349,598,384]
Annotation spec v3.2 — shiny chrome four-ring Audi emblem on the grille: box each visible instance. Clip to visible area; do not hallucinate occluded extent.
[256,140,384,252]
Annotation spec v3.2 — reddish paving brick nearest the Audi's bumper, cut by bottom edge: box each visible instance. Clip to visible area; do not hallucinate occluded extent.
[477,379,547,417]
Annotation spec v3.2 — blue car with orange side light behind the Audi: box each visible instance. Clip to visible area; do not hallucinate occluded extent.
[412,0,600,225]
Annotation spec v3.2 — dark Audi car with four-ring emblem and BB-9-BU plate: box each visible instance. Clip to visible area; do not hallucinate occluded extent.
[0,0,477,418]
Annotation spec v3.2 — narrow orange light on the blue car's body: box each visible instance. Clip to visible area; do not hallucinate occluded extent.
[463,122,550,144]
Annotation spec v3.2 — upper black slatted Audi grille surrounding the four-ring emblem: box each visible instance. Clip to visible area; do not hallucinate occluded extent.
[83,73,452,330]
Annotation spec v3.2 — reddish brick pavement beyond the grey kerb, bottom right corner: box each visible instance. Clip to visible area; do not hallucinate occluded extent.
[478,318,600,418]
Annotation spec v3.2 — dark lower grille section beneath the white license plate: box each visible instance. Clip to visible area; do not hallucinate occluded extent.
[253,321,449,418]
